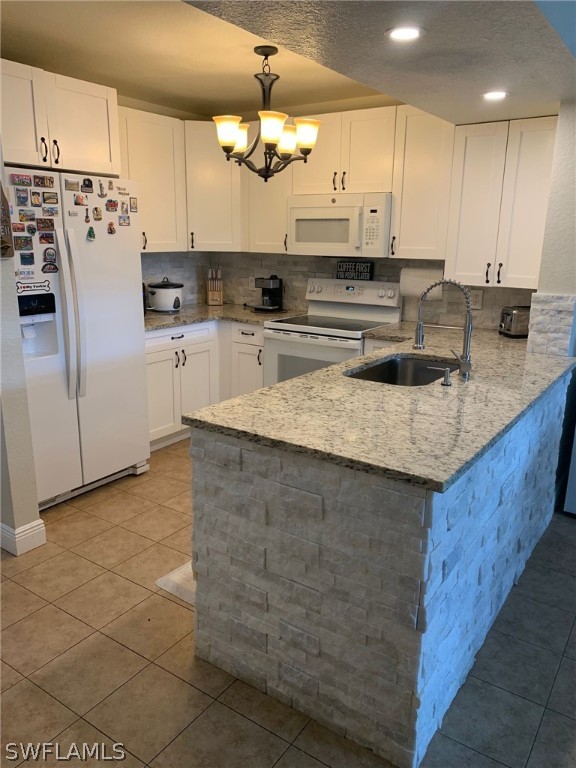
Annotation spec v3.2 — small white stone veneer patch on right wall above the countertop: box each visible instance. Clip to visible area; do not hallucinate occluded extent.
[528,293,576,357]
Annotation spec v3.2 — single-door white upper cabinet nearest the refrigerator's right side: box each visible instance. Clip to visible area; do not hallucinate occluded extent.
[119,107,188,252]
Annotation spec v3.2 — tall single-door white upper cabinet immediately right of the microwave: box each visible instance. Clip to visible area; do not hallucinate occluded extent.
[390,106,454,259]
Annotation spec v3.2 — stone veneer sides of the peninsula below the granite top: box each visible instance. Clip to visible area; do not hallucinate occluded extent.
[191,376,569,768]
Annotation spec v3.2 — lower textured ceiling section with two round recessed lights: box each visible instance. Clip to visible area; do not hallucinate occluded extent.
[187,0,576,123]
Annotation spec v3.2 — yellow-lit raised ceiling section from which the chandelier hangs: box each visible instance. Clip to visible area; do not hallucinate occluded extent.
[0,0,397,119]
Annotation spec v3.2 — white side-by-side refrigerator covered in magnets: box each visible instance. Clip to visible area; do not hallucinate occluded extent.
[5,167,150,507]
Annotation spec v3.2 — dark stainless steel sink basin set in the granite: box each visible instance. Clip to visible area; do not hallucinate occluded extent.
[345,355,459,387]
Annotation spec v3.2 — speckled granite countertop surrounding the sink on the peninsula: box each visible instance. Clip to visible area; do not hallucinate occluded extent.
[183,323,576,492]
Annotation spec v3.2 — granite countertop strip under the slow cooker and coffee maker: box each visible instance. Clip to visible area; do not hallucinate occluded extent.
[144,304,298,331]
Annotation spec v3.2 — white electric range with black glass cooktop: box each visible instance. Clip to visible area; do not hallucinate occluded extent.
[264,278,400,386]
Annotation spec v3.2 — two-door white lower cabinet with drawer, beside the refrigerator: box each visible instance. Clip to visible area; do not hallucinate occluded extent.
[146,322,218,441]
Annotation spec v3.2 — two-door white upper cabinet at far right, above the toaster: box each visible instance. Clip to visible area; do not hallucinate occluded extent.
[445,117,556,288]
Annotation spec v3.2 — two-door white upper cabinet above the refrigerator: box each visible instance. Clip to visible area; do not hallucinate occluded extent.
[2,60,120,174]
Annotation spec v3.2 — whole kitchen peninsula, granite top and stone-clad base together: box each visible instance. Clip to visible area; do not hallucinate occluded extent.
[184,324,576,768]
